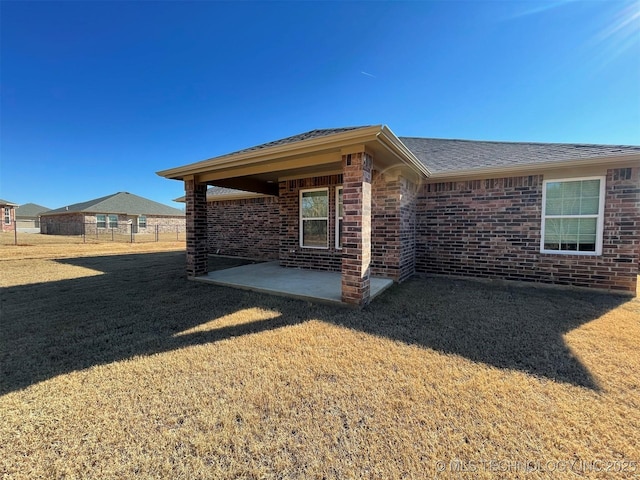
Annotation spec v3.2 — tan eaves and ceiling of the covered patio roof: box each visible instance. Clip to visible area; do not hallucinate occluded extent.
[158,125,430,195]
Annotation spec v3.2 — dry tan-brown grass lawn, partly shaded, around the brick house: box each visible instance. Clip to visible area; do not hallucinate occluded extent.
[0,244,640,479]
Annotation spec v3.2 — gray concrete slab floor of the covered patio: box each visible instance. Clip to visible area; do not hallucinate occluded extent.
[192,261,393,305]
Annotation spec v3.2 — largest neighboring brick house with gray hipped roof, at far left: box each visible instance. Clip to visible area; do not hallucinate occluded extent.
[40,192,185,235]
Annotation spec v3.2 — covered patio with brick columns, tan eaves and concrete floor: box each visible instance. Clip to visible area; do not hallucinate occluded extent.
[158,125,430,306]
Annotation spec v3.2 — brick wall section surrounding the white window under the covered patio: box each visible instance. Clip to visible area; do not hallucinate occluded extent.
[279,175,342,272]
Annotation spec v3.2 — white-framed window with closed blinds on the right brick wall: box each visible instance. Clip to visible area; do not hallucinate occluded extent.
[540,177,605,255]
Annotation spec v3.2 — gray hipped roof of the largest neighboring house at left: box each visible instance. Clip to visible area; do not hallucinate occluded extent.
[44,192,185,217]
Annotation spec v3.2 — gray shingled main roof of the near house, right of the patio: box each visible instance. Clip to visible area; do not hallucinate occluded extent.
[399,137,640,173]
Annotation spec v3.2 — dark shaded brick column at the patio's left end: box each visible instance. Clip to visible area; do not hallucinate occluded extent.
[184,179,208,277]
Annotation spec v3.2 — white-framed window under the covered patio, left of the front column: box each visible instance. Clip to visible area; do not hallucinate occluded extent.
[300,188,329,248]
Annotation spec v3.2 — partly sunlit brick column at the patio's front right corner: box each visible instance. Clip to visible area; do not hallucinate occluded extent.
[342,152,373,305]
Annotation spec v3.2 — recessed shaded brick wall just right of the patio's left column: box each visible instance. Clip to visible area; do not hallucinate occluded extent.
[207,197,280,260]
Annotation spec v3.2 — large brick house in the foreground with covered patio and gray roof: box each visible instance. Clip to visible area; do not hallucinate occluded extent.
[158,126,640,304]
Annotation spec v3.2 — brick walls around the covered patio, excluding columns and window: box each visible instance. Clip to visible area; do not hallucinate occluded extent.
[207,172,417,281]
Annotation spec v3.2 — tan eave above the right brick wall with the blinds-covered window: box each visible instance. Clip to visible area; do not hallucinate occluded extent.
[430,154,640,180]
